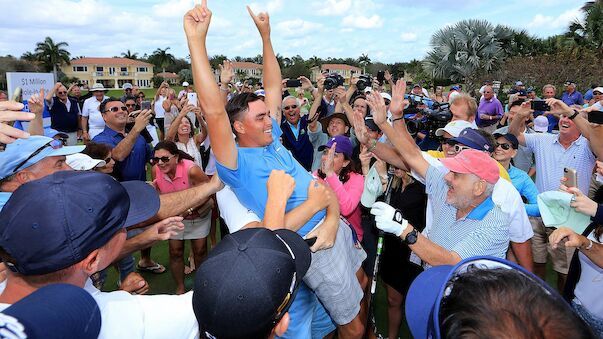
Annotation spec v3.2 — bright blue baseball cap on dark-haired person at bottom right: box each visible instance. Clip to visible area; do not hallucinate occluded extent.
[405,256,561,338]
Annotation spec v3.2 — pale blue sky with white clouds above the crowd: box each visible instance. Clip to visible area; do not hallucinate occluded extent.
[0,0,584,63]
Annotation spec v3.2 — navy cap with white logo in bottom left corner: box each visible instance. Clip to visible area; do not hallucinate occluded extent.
[0,284,101,339]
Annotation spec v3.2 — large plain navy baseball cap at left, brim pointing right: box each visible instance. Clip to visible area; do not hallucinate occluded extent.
[0,171,159,275]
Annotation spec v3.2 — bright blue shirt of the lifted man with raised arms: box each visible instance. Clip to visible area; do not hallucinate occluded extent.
[216,119,325,236]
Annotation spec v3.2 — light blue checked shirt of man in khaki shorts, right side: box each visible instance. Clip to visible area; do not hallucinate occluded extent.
[524,133,595,193]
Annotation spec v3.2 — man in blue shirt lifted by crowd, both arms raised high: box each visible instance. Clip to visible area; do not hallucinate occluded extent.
[184,0,364,338]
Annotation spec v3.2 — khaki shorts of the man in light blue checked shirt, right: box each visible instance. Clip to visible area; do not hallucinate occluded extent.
[530,217,574,274]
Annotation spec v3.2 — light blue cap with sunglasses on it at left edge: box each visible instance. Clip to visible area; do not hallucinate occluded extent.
[0,135,86,179]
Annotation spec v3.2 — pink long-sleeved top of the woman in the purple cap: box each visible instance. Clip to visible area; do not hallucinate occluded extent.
[315,172,364,240]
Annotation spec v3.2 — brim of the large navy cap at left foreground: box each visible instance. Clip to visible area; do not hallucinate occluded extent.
[121,181,160,227]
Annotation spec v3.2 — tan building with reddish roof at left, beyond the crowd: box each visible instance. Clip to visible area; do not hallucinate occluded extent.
[61,58,153,88]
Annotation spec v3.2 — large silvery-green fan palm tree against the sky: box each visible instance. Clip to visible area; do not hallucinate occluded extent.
[423,20,513,91]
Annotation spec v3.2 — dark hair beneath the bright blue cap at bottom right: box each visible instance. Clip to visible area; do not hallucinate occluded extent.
[436,268,594,338]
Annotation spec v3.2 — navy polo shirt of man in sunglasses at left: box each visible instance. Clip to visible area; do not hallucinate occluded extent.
[92,126,152,181]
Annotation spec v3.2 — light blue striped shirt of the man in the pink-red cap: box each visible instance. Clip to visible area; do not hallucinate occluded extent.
[424,165,510,259]
